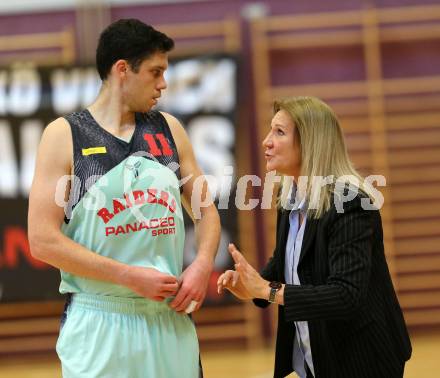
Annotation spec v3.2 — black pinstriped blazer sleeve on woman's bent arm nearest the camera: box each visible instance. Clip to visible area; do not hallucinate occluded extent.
[284,197,373,322]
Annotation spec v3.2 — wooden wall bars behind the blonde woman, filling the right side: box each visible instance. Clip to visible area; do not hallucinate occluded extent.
[251,2,440,327]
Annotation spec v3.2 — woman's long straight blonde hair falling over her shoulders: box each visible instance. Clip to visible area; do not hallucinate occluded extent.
[273,97,372,218]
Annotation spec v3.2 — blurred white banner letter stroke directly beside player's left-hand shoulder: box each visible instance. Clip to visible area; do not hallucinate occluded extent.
[20,119,44,196]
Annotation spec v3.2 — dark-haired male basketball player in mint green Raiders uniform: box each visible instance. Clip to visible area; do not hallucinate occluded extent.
[29,19,220,378]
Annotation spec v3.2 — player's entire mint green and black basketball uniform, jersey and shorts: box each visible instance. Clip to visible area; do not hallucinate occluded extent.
[56,110,200,378]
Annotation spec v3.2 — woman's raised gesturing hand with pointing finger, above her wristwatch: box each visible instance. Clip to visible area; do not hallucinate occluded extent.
[217,244,270,300]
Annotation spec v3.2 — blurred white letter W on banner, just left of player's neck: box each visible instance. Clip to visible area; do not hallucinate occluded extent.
[50,68,101,115]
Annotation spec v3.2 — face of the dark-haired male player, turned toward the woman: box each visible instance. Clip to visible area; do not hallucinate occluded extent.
[122,52,168,112]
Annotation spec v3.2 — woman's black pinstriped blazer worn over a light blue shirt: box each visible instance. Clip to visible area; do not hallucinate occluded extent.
[254,197,411,378]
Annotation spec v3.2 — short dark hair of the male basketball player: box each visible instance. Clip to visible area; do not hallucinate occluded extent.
[96,18,174,80]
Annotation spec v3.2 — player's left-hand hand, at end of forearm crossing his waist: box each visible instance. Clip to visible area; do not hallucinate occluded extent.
[123,266,179,302]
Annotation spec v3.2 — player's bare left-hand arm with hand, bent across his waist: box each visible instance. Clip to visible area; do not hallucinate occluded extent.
[28,118,177,300]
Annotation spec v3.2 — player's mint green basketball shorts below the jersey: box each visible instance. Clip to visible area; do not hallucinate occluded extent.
[56,294,199,378]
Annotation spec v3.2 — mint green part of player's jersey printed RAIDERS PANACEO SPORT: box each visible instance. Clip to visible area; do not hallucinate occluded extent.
[60,157,185,297]
